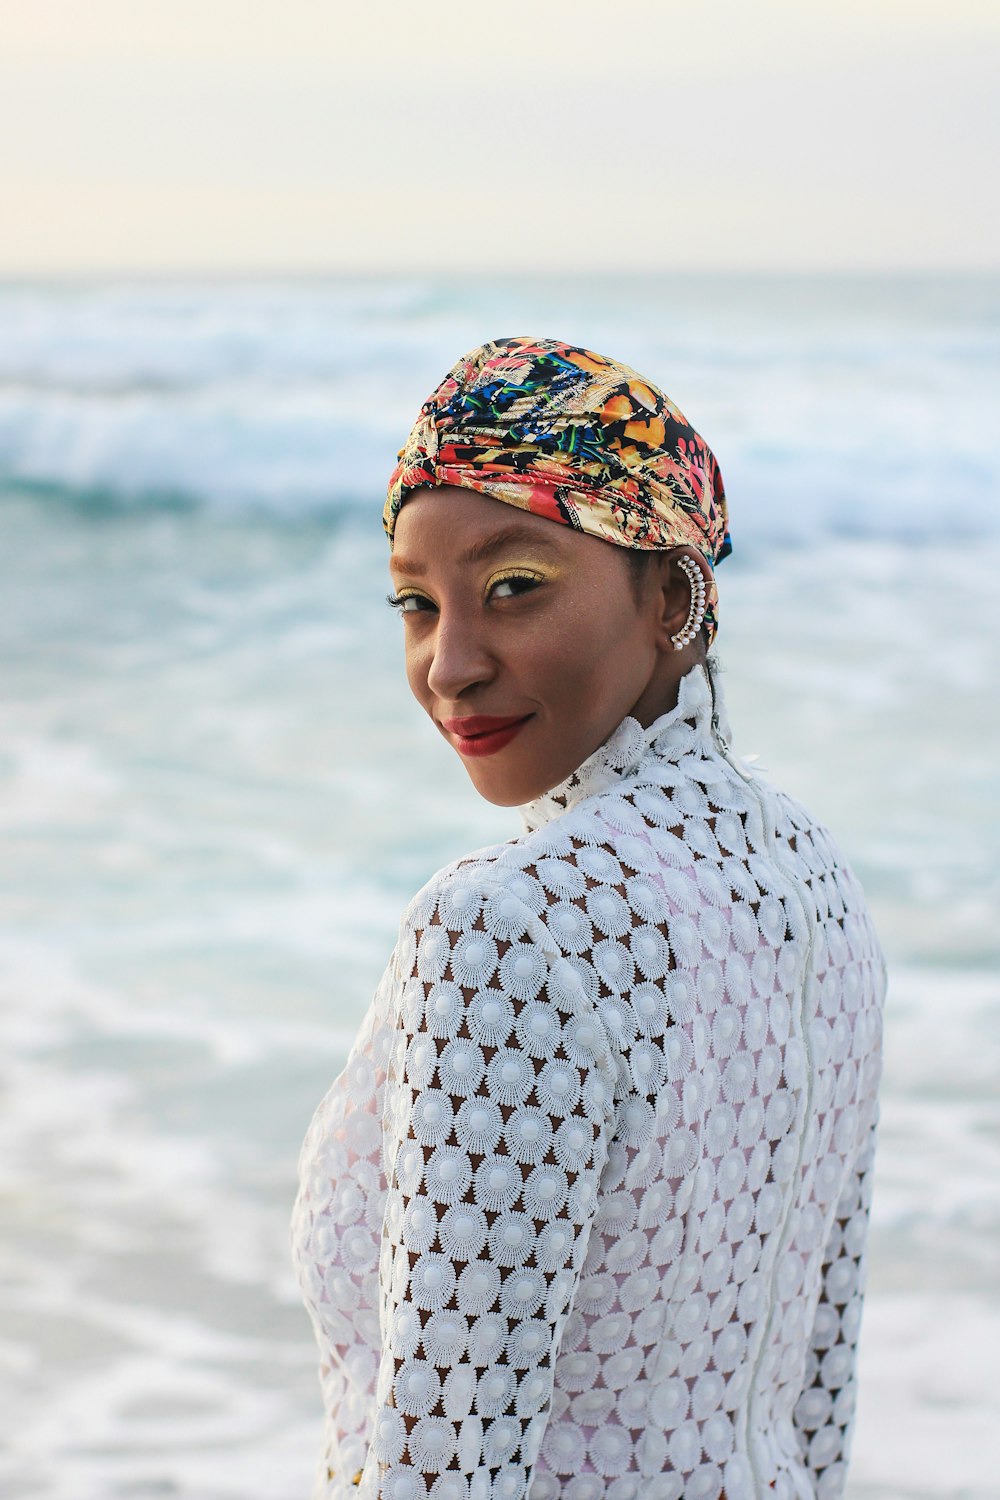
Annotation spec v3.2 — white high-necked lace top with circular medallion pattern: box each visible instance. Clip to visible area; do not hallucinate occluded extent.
[294,662,885,1500]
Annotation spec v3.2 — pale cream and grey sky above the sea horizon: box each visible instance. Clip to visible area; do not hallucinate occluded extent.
[0,0,1000,275]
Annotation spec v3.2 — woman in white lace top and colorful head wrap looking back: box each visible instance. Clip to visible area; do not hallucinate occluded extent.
[295,338,885,1500]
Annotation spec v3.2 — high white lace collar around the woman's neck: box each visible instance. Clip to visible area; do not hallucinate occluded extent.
[519,656,732,833]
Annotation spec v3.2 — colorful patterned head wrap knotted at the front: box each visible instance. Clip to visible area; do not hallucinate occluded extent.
[382,338,732,642]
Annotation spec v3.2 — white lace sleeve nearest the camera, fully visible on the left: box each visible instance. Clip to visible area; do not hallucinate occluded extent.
[361,867,615,1500]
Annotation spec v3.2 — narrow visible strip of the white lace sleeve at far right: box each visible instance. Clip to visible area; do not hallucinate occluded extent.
[795,1122,877,1500]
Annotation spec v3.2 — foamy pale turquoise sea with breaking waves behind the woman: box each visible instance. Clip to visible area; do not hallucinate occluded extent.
[0,276,1000,1500]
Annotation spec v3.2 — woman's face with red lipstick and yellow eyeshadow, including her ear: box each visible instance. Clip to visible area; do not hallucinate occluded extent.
[390,486,690,807]
